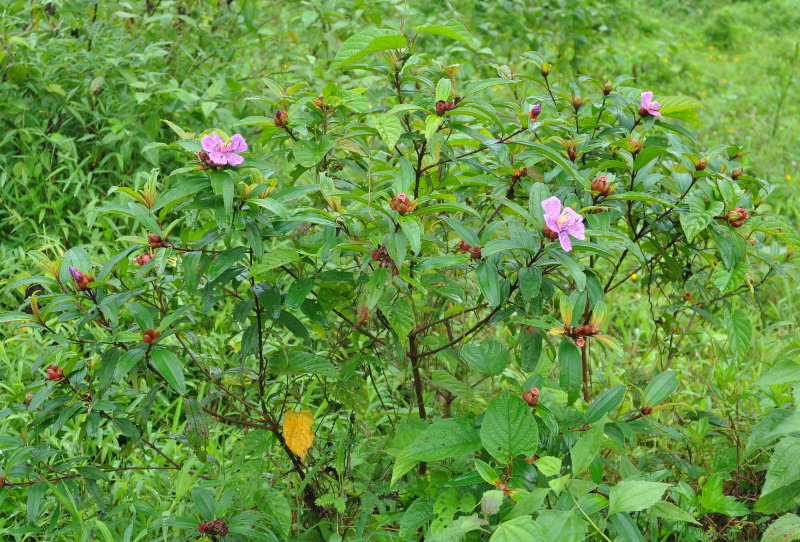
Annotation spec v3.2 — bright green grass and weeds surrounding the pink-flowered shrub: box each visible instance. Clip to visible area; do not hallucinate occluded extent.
[0,0,800,541]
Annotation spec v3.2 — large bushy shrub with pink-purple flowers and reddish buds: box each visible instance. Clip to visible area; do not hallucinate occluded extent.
[2,22,800,542]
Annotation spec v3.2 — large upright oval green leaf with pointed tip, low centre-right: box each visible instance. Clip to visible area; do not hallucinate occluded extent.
[481,392,539,464]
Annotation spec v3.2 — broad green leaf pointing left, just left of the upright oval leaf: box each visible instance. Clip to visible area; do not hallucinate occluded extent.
[405,418,481,461]
